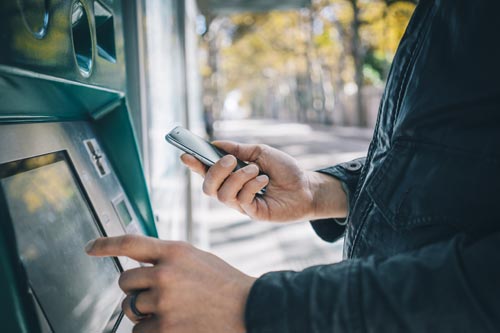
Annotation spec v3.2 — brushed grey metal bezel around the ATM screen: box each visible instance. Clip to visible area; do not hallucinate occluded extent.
[0,121,143,332]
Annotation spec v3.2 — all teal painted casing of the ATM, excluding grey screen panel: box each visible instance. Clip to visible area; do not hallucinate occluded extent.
[0,0,153,333]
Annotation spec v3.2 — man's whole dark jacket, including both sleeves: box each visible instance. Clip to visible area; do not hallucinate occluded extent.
[246,0,500,333]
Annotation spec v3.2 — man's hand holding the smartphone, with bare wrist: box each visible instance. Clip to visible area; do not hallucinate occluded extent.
[181,141,347,222]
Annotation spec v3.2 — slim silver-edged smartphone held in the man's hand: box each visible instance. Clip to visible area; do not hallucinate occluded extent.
[165,126,266,195]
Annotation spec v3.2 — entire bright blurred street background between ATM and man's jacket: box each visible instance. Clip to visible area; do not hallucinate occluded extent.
[139,0,417,275]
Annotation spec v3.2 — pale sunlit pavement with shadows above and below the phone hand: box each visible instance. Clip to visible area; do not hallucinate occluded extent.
[207,120,372,276]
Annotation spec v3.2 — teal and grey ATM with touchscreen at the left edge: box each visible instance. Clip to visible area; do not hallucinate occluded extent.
[0,0,157,333]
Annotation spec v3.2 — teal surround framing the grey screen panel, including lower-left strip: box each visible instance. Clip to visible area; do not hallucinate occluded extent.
[0,66,158,333]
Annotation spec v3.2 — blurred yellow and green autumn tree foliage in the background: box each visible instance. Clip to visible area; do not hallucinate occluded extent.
[201,0,415,122]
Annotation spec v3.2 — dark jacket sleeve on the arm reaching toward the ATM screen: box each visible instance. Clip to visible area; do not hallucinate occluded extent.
[246,233,500,333]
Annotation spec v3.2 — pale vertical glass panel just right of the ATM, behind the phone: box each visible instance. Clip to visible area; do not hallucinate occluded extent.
[143,0,187,239]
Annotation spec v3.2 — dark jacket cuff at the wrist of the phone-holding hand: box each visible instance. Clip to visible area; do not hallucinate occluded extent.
[311,157,366,242]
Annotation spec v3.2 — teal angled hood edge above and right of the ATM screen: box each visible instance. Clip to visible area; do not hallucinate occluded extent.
[0,70,158,237]
